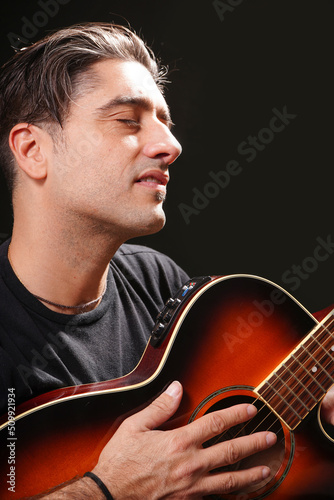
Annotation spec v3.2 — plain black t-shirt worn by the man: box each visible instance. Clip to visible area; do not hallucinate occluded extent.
[0,242,188,414]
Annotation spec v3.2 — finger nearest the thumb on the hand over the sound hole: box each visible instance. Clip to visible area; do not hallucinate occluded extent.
[182,404,257,445]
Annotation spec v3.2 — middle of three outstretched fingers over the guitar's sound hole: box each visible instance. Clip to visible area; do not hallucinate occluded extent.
[201,431,277,471]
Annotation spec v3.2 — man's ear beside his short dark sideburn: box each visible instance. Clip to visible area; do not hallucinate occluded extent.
[9,123,51,180]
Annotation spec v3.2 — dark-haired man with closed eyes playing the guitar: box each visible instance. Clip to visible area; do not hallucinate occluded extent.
[0,25,332,500]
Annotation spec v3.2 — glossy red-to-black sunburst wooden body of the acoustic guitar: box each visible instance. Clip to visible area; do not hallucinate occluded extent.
[0,275,334,500]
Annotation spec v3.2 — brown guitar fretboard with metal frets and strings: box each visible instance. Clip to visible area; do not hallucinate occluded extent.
[255,311,334,429]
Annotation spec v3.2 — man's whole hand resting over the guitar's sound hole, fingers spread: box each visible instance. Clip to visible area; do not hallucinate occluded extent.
[93,382,276,500]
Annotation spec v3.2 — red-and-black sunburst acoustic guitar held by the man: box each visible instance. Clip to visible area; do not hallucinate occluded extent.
[0,275,334,500]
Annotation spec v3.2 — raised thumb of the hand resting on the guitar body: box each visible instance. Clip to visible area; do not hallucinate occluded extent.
[136,381,182,431]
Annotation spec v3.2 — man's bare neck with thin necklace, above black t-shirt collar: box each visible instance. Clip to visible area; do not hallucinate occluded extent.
[9,224,123,314]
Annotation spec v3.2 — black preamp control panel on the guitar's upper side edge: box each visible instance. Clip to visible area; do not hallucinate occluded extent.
[151,276,212,347]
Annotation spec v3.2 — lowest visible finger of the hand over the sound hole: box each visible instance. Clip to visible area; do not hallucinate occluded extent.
[200,466,271,495]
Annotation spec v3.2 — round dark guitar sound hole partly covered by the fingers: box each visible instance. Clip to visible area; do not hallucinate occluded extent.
[203,395,286,498]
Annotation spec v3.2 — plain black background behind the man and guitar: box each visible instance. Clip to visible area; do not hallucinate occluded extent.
[0,0,334,311]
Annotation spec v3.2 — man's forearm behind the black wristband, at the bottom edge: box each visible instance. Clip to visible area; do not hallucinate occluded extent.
[33,477,105,500]
